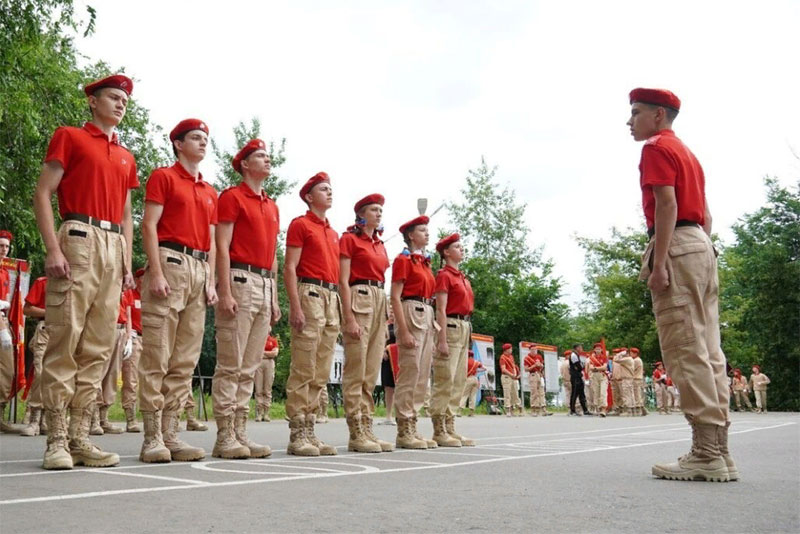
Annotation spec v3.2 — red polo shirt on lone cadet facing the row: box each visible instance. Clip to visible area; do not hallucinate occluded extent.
[639,130,706,232]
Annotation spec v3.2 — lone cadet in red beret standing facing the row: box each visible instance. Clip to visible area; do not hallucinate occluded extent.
[628,88,738,481]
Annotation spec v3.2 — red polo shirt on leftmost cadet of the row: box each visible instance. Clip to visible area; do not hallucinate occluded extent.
[44,122,139,224]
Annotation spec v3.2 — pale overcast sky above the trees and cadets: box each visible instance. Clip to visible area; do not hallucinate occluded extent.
[72,0,800,305]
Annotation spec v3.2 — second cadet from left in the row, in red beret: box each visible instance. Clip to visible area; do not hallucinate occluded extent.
[139,119,217,462]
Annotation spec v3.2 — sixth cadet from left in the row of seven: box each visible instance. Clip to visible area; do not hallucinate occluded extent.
[391,215,436,449]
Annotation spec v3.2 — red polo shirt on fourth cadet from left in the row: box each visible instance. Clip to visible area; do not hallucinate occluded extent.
[286,210,339,284]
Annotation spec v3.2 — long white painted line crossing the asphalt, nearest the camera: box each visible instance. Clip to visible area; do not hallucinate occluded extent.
[0,422,797,505]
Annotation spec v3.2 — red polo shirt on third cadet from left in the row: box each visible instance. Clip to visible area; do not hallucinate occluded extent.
[219,182,280,269]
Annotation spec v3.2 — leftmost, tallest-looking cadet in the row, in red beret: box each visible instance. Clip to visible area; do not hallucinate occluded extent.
[33,75,139,469]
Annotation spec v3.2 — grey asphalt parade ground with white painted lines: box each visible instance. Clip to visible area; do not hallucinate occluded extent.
[0,413,800,534]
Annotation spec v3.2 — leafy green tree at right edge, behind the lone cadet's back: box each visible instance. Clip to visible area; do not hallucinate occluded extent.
[721,178,800,411]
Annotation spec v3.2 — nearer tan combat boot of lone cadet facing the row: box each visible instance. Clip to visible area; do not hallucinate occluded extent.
[652,423,730,482]
